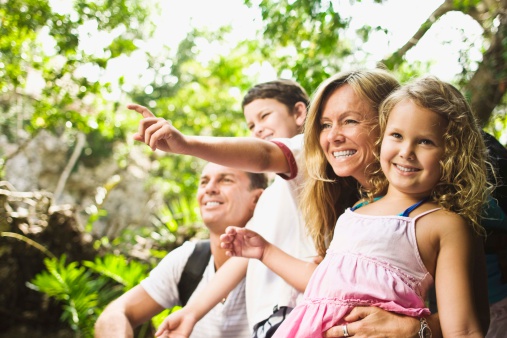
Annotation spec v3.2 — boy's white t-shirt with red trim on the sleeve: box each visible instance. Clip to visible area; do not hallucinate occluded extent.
[246,134,317,328]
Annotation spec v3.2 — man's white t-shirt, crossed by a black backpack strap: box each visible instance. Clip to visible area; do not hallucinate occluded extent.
[141,242,251,338]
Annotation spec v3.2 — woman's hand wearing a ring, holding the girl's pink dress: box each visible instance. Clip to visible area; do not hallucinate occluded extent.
[324,307,420,338]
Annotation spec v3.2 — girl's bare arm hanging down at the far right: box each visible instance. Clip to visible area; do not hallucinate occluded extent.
[434,213,489,337]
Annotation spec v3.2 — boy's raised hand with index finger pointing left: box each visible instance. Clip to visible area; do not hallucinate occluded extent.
[127,104,187,154]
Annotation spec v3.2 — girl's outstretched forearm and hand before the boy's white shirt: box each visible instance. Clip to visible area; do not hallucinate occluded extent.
[220,226,317,292]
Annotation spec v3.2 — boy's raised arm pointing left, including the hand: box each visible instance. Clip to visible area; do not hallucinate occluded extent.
[127,104,290,173]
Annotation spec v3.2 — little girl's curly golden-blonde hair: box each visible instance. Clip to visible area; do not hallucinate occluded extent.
[368,76,492,234]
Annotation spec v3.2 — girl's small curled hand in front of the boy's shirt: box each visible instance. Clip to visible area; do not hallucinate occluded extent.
[220,226,269,259]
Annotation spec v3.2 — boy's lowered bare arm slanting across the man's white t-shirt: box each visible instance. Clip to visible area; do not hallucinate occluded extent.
[156,258,248,337]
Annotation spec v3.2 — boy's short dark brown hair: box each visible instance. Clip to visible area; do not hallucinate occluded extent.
[241,79,310,112]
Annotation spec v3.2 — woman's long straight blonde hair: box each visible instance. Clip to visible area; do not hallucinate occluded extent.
[300,68,399,256]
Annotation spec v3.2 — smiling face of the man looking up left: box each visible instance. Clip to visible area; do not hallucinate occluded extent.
[197,163,262,233]
